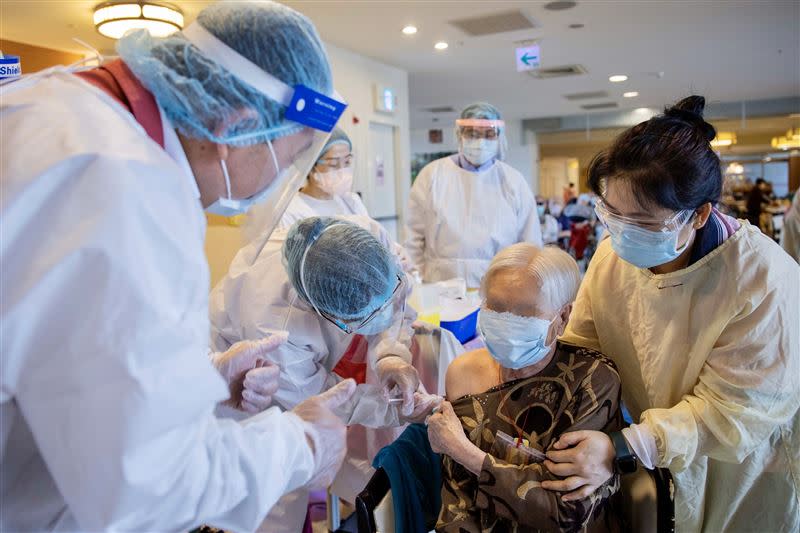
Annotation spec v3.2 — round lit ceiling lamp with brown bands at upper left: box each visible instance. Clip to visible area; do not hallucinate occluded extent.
[94,1,183,39]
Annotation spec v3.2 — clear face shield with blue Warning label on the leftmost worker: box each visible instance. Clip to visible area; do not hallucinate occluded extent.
[183,22,347,248]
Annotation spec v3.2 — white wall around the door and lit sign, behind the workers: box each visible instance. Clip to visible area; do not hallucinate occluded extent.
[326,44,411,238]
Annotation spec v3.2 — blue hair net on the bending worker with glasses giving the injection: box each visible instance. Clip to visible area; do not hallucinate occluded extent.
[283,217,398,320]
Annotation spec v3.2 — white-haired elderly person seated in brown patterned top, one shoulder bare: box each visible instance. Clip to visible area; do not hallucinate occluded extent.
[428,243,622,533]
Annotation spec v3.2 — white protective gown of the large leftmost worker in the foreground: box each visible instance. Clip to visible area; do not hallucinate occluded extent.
[0,71,313,531]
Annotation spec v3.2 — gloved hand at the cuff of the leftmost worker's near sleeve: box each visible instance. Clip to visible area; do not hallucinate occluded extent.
[292,379,356,489]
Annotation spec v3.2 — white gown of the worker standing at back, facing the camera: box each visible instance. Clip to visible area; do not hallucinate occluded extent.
[405,157,542,288]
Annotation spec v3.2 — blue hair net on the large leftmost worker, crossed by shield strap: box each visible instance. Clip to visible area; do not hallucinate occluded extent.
[117,2,332,145]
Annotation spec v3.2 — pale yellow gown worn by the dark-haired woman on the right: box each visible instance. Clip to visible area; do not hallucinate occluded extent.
[563,222,800,532]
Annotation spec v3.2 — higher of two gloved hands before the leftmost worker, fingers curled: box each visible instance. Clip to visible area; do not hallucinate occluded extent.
[211,331,289,413]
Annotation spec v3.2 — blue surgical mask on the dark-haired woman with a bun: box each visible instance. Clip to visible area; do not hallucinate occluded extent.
[609,221,691,268]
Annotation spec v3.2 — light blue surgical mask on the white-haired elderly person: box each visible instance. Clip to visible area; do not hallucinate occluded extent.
[478,307,555,370]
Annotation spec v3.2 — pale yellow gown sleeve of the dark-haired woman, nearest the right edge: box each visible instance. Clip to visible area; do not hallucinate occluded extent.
[642,278,800,471]
